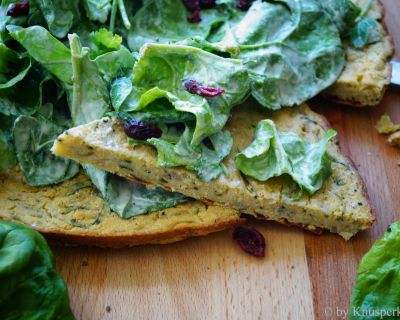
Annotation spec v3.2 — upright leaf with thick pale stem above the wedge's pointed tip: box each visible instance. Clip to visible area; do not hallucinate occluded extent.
[68,34,110,125]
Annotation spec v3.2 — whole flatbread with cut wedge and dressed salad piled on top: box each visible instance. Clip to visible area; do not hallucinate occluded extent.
[0,0,391,246]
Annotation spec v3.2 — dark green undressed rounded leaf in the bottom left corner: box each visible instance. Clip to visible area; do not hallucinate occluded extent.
[0,221,74,320]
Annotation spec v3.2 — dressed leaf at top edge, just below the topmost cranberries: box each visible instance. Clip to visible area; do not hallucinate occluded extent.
[128,0,230,51]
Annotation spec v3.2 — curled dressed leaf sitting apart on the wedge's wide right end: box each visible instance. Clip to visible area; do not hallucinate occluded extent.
[235,120,336,194]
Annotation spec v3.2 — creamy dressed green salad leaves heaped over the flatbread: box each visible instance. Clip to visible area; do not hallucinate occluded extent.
[0,0,380,218]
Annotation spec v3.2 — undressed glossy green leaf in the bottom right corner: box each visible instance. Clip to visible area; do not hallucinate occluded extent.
[349,221,400,320]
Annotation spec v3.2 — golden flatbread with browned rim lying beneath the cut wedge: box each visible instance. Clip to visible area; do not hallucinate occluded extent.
[0,169,244,248]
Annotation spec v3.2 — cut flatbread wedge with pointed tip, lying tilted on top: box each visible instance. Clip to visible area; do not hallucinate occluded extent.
[53,103,374,239]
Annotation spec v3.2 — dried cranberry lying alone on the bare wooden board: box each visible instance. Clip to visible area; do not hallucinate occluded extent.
[233,226,265,258]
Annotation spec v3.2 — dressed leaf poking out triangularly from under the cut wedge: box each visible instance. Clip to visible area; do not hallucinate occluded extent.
[83,165,189,219]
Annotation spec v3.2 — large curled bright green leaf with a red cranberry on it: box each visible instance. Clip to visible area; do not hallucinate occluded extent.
[113,44,249,145]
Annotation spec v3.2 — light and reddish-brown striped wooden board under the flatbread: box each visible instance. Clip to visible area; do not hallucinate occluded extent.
[54,0,400,319]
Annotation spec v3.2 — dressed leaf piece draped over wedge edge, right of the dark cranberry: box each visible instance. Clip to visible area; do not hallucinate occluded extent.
[147,126,232,181]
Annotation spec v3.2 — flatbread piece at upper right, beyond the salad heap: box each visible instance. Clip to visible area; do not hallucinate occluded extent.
[323,0,394,107]
